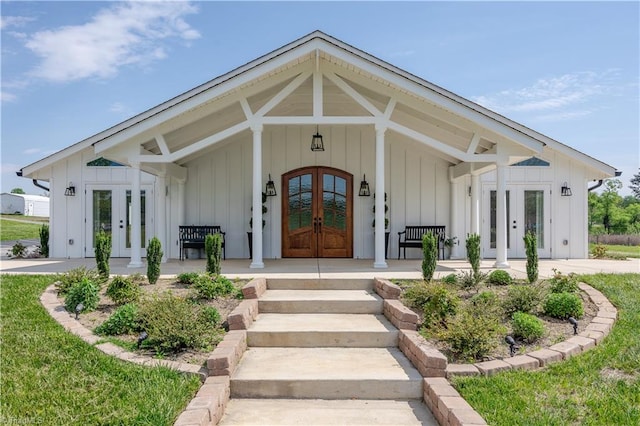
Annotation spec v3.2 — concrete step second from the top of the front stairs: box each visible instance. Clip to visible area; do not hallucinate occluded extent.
[258,290,383,314]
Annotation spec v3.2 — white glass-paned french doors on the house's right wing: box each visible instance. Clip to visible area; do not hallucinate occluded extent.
[483,185,551,258]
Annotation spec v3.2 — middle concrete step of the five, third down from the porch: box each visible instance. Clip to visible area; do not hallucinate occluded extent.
[247,314,398,348]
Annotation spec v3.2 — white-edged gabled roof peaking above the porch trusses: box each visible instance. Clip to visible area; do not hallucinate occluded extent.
[19,31,615,176]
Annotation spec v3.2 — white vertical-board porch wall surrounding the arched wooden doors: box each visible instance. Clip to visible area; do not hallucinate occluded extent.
[180,125,450,259]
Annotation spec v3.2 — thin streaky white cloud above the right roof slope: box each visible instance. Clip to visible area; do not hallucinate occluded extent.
[473,70,616,121]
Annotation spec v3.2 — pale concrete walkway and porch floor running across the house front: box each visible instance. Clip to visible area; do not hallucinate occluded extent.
[0,253,640,279]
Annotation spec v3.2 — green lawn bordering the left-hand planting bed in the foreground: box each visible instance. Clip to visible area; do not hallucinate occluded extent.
[0,275,199,425]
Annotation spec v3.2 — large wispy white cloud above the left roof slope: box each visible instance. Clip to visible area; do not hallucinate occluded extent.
[26,1,200,82]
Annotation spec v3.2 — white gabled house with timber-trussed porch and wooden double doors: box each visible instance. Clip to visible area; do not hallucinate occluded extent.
[19,31,616,268]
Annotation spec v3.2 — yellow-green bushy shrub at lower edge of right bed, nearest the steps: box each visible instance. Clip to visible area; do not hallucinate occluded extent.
[438,306,506,361]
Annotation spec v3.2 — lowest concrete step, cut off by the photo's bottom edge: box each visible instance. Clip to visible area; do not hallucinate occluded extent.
[218,399,438,426]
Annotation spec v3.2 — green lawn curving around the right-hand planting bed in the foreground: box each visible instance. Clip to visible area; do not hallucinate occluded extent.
[454,274,640,426]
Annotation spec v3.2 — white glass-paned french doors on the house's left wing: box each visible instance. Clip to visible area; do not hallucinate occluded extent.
[85,185,152,257]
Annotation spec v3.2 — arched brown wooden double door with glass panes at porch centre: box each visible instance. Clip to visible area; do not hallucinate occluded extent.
[282,167,353,258]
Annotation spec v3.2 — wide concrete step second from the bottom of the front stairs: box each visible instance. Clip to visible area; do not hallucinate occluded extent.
[231,348,422,400]
